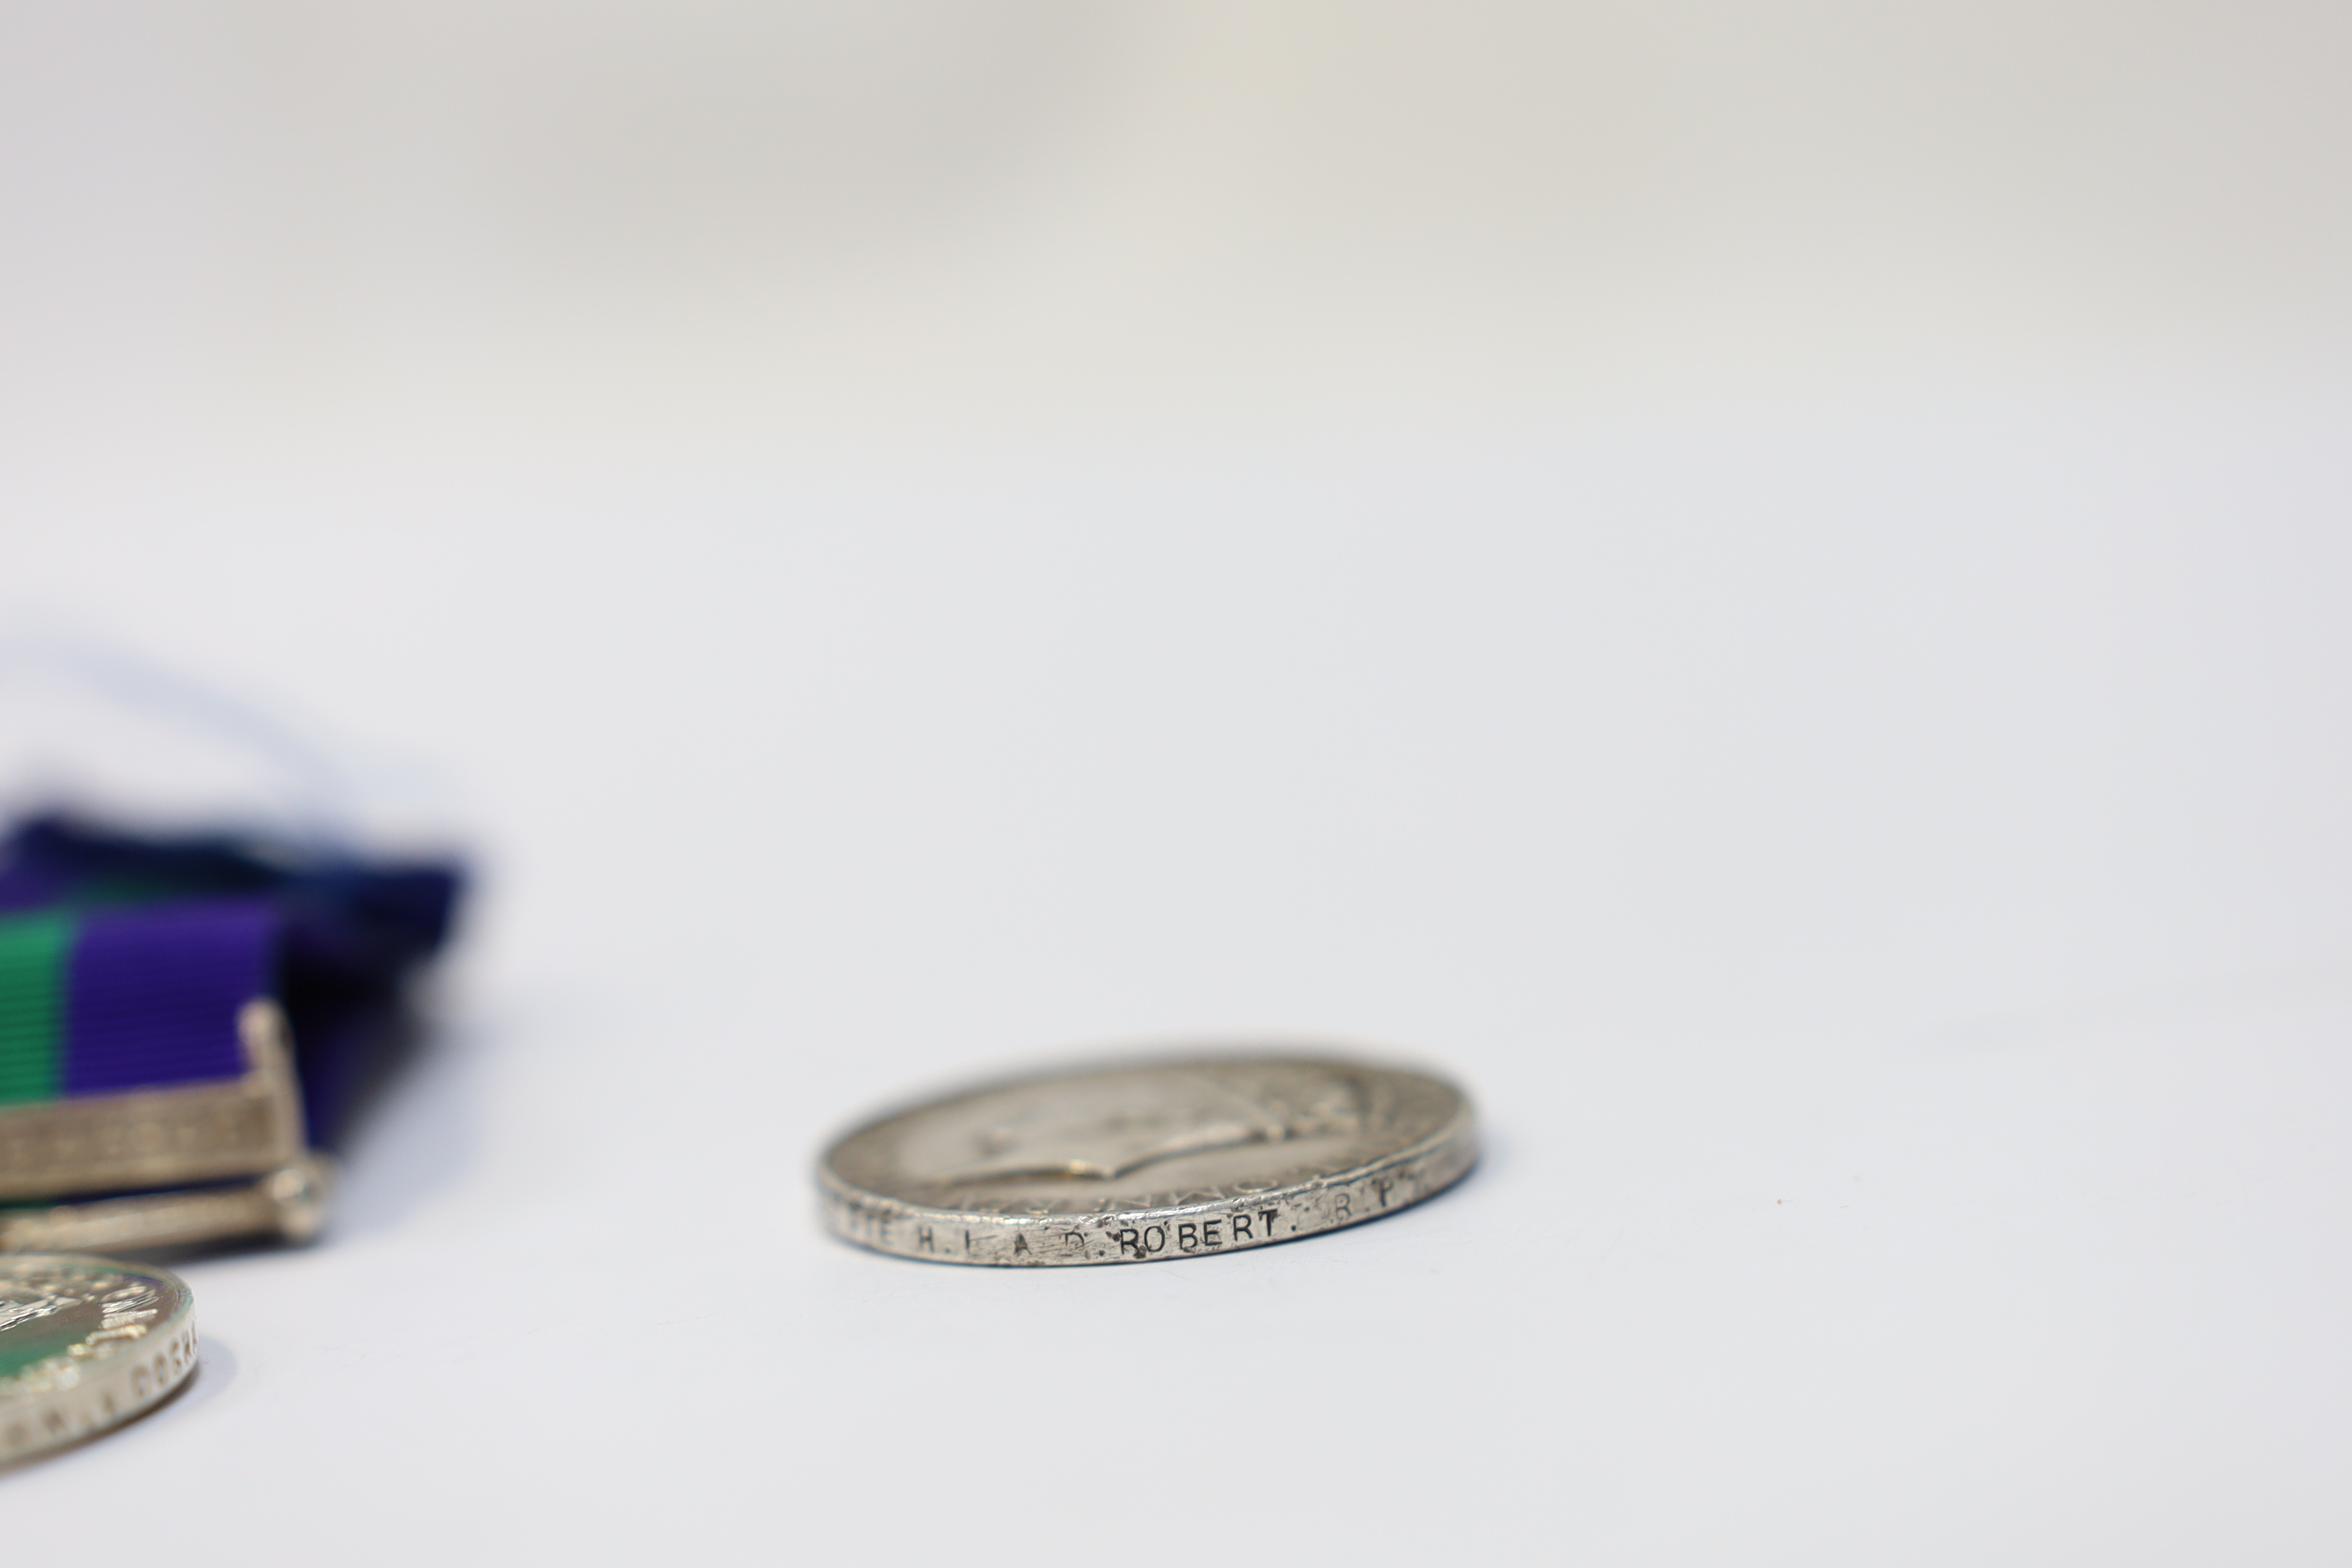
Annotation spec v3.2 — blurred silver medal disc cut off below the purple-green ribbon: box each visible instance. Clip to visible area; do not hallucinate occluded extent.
[0,1253,195,1465]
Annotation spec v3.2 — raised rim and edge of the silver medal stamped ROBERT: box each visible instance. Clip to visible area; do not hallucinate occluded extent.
[816,1046,1480,1267]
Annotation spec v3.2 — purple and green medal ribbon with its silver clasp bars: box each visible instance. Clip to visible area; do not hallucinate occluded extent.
[0,820,459,1253]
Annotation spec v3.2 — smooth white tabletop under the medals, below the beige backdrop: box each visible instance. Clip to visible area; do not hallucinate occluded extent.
[0,419,2352,1563]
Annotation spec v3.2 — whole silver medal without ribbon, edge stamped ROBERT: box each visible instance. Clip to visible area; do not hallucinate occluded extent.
[818,1056,1477,1265]
